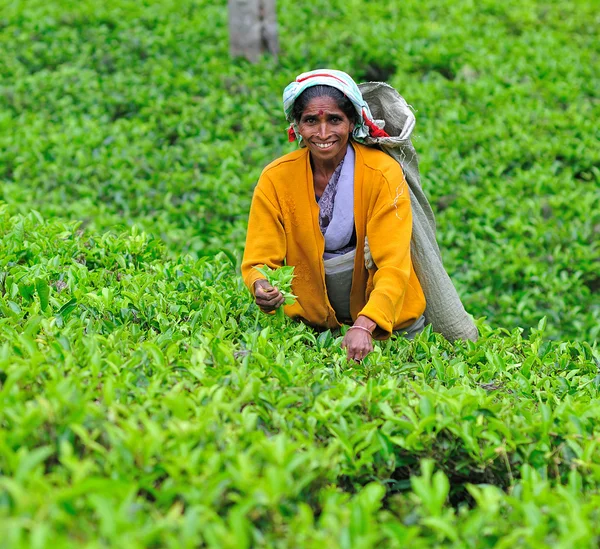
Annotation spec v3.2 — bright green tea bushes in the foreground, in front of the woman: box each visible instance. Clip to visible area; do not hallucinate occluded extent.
[0,206,600,548]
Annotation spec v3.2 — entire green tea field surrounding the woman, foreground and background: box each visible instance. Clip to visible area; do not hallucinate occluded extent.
[0,0,600,549]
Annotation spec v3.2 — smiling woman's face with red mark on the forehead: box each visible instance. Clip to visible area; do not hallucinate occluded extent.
[297,96,354,163]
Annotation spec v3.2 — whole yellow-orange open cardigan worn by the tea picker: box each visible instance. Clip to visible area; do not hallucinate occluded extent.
[242,142,425,337]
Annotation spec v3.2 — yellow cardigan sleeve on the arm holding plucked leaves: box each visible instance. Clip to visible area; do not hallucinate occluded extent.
[242,174,286,295]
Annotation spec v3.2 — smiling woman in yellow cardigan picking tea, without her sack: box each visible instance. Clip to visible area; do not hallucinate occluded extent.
[242,70,425,361]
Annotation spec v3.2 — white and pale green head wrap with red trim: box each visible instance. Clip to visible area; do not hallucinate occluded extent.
[283,69,389,143]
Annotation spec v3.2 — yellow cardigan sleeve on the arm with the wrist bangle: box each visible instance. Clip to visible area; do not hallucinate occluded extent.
[359,166,412,337]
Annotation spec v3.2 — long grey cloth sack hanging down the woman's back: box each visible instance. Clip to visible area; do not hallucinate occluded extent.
[358,82,478,341]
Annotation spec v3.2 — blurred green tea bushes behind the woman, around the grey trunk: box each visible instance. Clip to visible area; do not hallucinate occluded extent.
[0,0,600,341]
